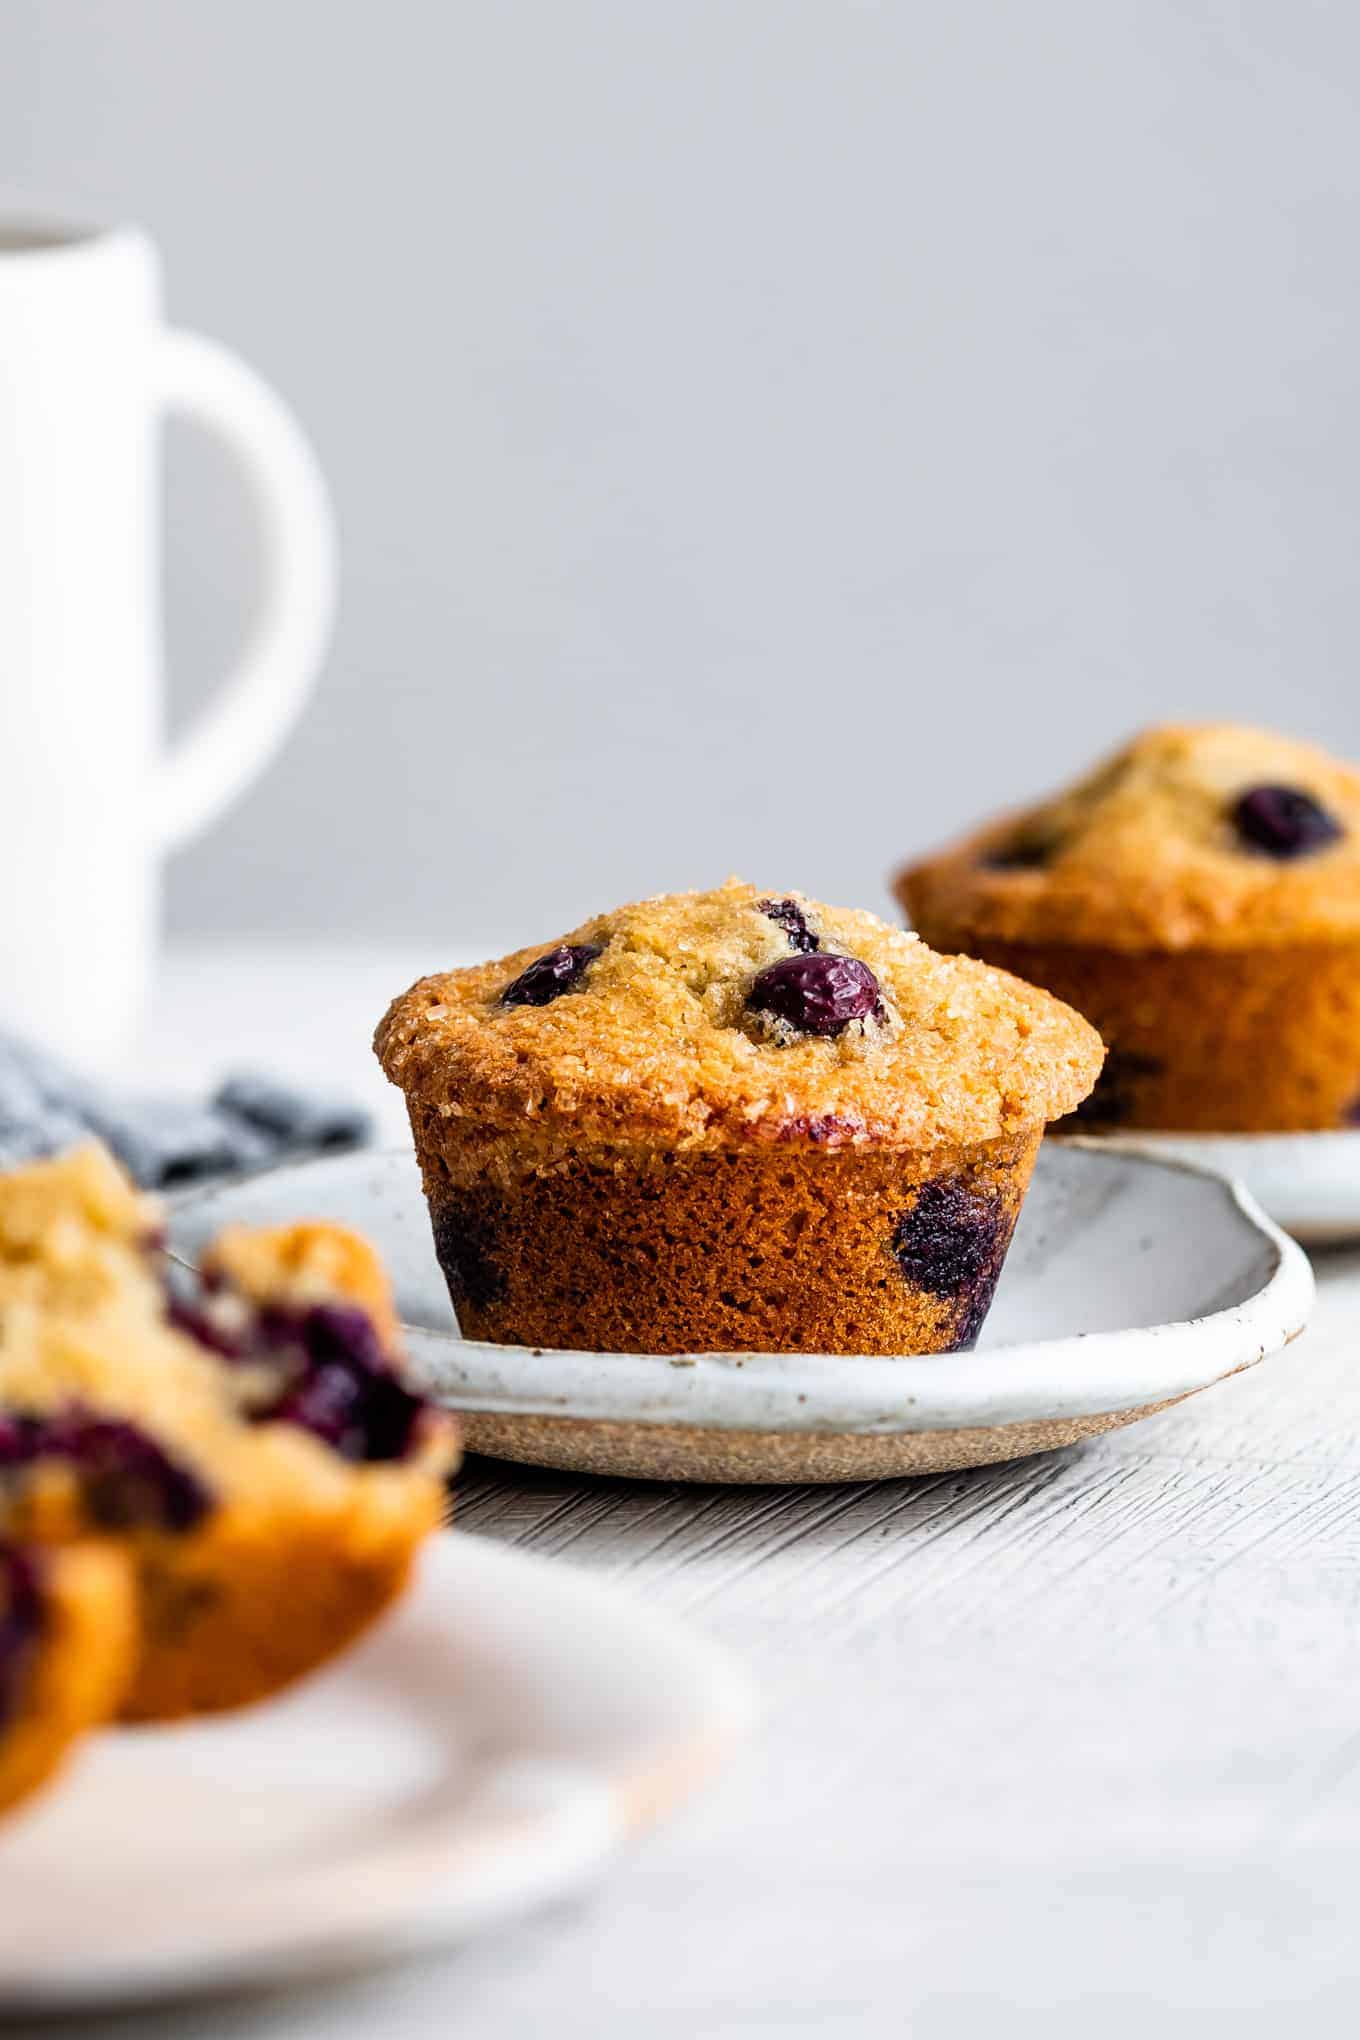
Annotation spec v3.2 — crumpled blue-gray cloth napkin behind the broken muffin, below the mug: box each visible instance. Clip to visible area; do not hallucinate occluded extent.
[0,1034,373,1189]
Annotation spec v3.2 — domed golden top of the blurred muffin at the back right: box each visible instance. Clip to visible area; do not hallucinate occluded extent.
[895,722,1360,951]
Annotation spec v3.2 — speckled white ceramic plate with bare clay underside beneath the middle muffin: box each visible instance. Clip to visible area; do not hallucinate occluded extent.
[171,1140,1313,1481]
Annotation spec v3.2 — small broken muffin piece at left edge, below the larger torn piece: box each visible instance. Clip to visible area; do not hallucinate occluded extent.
[0,1542,137,1814]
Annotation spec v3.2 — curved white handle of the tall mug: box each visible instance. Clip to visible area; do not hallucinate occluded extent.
[151,333,336,851]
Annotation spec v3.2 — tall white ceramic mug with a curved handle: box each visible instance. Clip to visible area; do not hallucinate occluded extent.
[0,224,334,1067]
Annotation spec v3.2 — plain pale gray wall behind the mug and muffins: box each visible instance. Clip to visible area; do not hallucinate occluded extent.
[0,0,1360,961]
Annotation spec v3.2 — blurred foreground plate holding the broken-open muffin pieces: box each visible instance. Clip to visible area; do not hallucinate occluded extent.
[0,1530,750,2016]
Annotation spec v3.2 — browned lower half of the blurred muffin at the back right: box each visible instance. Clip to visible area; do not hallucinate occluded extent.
[958,930,1360,1132]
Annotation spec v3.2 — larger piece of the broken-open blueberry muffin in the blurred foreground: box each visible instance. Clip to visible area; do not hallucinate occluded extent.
[0,1146,455,1718]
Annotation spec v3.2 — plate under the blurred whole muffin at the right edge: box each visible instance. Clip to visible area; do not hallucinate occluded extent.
[1076,1130,1360,1246]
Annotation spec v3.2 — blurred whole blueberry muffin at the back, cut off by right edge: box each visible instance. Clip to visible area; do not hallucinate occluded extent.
[897,724,1360,1132]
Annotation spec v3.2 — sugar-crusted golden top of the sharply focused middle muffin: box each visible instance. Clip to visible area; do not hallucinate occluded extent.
[375,879,1103,1153]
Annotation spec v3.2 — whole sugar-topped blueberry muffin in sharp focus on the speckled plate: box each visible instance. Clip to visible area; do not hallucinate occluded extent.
[375,881,1101,1353]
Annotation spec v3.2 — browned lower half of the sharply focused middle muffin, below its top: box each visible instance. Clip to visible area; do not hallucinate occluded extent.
[416,1126,1042,1355]
